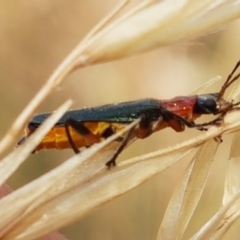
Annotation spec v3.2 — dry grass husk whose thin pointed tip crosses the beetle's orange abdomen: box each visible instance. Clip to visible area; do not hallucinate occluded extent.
[0,121,137,239]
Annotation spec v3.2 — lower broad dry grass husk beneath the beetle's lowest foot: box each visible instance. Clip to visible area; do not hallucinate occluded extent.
[3,147,191,239]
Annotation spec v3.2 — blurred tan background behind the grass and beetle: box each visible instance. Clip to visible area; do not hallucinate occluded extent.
[0,0,240,240]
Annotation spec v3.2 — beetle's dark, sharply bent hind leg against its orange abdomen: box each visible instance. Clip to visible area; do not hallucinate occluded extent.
[65,118,99,154]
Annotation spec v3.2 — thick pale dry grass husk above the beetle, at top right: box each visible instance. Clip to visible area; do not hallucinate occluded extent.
[75,0,240,63]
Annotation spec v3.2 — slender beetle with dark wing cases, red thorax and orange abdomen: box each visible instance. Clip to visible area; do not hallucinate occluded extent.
[17,61,240,167]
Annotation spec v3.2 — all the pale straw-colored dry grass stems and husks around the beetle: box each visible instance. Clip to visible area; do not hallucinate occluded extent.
[0,0,240,240]
